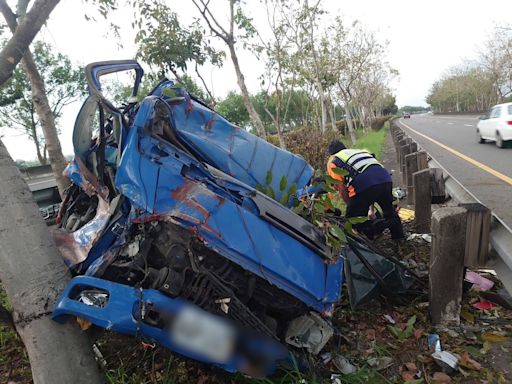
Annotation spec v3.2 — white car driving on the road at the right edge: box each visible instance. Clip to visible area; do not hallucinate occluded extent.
[476,103,512,148]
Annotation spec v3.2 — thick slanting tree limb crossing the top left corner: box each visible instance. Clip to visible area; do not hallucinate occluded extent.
[0,0,59,86]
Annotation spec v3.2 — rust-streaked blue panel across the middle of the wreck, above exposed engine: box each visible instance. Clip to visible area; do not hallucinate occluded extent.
[116,106,343,311]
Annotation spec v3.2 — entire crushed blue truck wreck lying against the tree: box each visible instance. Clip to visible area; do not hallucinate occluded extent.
[53,61,343,374]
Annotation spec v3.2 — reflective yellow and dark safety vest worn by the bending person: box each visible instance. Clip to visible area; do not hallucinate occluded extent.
[327,149,382,195]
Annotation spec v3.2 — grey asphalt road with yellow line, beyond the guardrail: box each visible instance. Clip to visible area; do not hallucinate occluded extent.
[399,115,512,227]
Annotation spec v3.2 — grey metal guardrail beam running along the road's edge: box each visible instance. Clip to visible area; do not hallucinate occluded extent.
[397,121,512,294]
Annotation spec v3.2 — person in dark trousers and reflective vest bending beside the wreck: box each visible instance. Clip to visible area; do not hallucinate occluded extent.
[327,140,404,240]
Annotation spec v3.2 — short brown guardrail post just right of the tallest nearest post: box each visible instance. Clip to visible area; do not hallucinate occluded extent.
[459,203,491,268]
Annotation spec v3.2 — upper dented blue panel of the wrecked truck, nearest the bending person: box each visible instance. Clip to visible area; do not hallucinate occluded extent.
[153,81,313,200]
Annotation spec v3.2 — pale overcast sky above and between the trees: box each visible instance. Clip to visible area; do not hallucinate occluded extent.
[2,0,512,160]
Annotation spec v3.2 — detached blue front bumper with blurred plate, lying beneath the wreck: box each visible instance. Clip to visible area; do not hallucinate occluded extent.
[53,276,293,376]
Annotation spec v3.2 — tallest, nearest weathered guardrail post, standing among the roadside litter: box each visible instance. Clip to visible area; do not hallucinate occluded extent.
[429,207,467,325]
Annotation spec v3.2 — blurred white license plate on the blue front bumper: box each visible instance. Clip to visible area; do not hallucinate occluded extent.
[171,307,236,363]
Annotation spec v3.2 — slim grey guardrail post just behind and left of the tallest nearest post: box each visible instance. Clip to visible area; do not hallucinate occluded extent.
[412,169,432,233]
